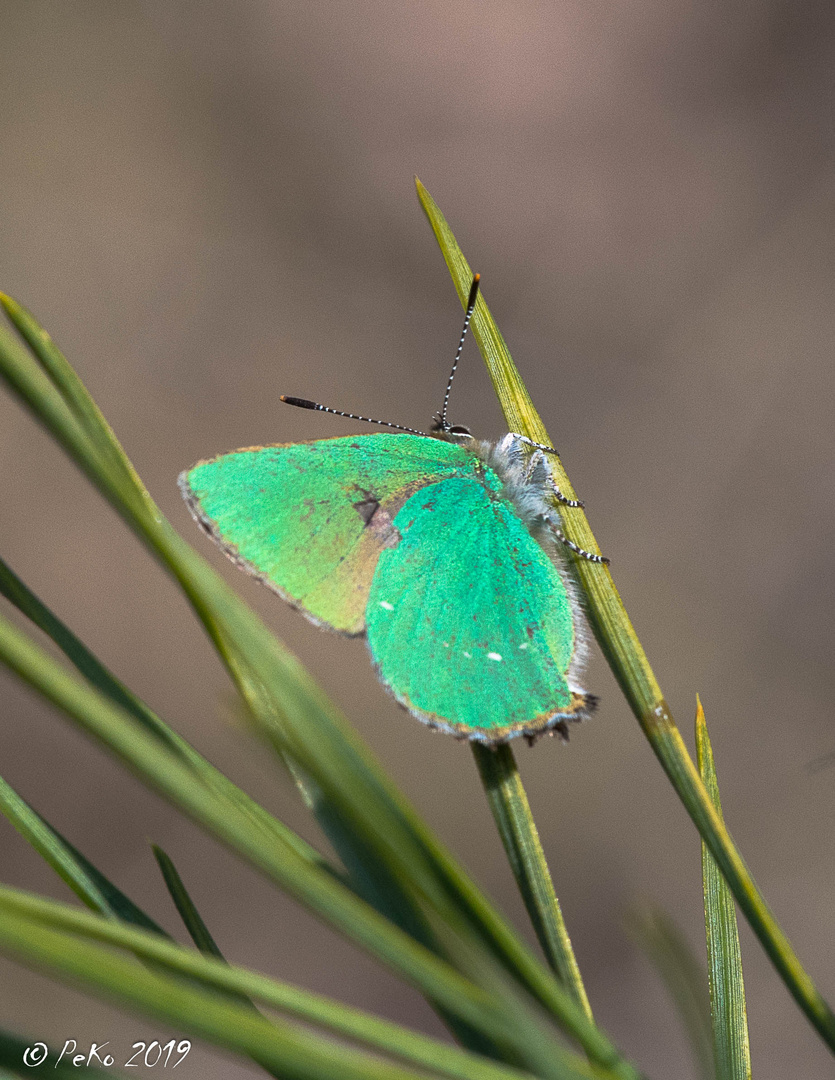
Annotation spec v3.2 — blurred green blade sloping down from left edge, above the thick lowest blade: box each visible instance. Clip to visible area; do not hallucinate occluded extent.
[0,888,611,1080]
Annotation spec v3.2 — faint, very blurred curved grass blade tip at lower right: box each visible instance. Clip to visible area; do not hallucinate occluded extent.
[628,908,716,1080]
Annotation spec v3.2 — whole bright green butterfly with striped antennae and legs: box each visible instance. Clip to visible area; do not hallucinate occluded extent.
[179,274,608,745]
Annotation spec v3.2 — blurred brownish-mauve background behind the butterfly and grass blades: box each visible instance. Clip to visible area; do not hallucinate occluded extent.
[0,0,835,1080]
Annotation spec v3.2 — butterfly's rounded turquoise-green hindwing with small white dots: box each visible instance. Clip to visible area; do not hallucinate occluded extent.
[366,470,592,743]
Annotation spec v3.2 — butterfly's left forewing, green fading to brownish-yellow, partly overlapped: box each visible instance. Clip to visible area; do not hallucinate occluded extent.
[179,433,471,634]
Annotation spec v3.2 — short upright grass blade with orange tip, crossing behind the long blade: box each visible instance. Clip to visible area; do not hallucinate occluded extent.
[696,699,751,1080]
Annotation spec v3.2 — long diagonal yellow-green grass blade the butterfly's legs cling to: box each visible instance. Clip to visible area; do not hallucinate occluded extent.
[417,180,835,1051]
